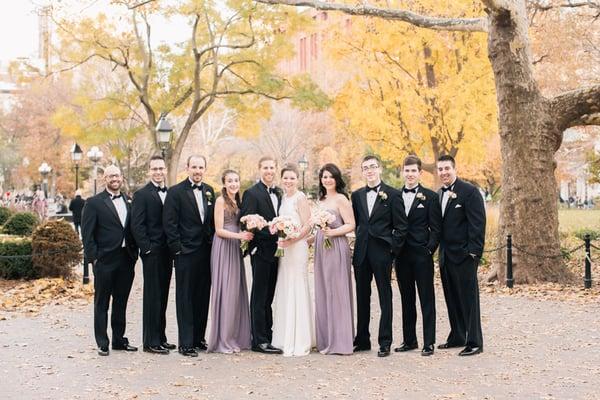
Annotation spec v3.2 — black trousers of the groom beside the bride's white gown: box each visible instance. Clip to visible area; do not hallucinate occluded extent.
[250,256,278,346]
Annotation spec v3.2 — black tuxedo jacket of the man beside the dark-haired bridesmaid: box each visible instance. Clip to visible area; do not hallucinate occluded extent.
[351,182,407,266]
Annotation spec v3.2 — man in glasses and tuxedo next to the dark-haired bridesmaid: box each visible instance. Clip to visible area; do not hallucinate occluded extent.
[352,156,407,357]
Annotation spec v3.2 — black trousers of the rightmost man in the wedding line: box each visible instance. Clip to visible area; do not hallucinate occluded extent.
[440,256,483,347]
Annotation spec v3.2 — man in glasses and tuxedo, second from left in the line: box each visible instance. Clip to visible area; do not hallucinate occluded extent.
[131,156,176,354]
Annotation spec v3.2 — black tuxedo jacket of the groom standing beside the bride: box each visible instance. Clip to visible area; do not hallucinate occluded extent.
[240,181,281,260]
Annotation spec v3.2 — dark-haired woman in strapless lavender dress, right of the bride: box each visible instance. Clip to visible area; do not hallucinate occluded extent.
[315,164,354,354]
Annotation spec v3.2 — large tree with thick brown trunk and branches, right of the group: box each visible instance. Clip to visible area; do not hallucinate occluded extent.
[257,0,600,282]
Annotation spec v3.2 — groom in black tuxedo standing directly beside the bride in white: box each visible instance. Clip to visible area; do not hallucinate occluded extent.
[241,156,282,354]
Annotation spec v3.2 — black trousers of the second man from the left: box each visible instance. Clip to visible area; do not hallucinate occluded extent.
[142,247,173,347]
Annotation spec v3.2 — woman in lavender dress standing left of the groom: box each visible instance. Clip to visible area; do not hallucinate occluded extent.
[208,170,252,353]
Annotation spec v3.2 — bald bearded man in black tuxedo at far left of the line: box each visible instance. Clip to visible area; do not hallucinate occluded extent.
[81,165,138,356]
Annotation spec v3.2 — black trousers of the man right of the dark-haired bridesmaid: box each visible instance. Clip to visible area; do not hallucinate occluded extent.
[354,240,392,347]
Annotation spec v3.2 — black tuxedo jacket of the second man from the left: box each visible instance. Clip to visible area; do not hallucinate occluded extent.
[131,182,167,254]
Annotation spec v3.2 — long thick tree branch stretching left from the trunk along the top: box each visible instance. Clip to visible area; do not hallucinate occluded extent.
[255,0,487,32]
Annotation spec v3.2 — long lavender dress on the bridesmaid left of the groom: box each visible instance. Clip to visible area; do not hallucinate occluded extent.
[208,208,250,353]
